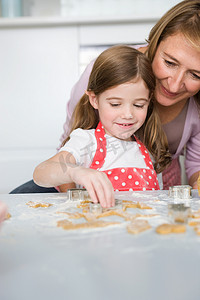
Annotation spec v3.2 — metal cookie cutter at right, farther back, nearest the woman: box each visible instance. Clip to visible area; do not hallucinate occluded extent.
[169,185,192,200]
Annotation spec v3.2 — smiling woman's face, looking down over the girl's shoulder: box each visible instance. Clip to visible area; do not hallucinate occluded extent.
[152,33,200,106]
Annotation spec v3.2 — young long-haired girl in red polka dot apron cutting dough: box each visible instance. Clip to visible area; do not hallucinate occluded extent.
[33,46,171,207]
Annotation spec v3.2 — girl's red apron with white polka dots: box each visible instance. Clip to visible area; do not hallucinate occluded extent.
[90,122,160,191]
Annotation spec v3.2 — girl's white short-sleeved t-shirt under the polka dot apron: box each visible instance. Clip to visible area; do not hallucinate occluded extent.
[60,128,163,188]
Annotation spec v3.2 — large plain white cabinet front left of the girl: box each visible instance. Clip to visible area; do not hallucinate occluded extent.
[0,26,78,193]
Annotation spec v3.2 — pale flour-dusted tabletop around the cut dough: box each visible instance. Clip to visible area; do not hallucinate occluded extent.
[0,190,200,300]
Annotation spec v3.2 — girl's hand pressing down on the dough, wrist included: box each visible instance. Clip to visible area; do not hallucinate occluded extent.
[69,165,115,207]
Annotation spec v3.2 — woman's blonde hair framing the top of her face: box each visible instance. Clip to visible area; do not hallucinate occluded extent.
[146,0,200,107]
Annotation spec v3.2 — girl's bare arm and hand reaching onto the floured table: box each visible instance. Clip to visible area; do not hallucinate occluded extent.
[33,151,115,207]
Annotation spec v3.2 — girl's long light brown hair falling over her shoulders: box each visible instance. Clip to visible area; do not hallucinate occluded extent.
[63,45,171,172]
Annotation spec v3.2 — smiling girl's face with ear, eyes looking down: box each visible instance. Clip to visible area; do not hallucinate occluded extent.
[88,78,149,141]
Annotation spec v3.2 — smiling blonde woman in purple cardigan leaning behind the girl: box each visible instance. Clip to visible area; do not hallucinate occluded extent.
[12,0,200,193]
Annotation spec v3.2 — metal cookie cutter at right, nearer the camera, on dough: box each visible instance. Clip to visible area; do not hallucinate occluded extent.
[168,203,191,223]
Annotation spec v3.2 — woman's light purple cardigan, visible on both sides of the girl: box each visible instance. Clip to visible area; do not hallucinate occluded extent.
[58,60,200,178]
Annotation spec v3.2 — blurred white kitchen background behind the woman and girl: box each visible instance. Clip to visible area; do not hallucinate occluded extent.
[0,0,180,193]
